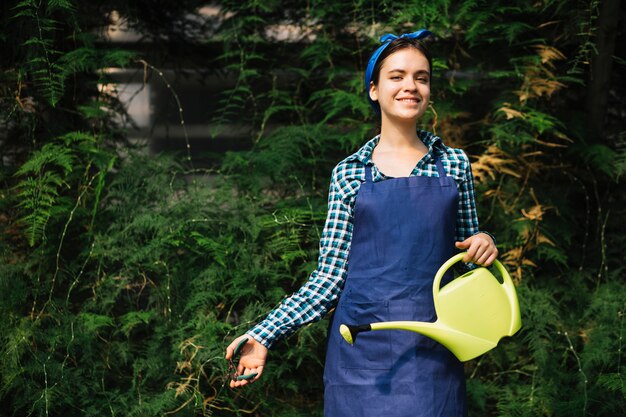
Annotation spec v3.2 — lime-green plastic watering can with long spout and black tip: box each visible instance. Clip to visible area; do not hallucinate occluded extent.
[339,253,522,362]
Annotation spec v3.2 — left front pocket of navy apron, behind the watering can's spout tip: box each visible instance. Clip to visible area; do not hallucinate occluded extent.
[339,301,393,370]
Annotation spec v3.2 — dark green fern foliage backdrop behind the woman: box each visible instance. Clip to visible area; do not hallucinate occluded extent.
[0,0,626,417]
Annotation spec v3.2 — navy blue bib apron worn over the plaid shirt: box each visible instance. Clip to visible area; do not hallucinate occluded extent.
[324,159,467,417]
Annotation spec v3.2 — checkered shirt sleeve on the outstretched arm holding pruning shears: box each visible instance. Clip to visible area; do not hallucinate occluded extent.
[247,166,352,348]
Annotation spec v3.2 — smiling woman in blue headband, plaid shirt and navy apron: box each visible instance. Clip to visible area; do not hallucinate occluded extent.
[226,30,498,417]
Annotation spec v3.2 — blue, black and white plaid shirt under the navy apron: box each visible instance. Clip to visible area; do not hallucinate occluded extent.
[247,130,495,348]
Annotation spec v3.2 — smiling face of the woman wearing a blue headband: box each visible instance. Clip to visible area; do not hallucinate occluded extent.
[370,48,430,120]
